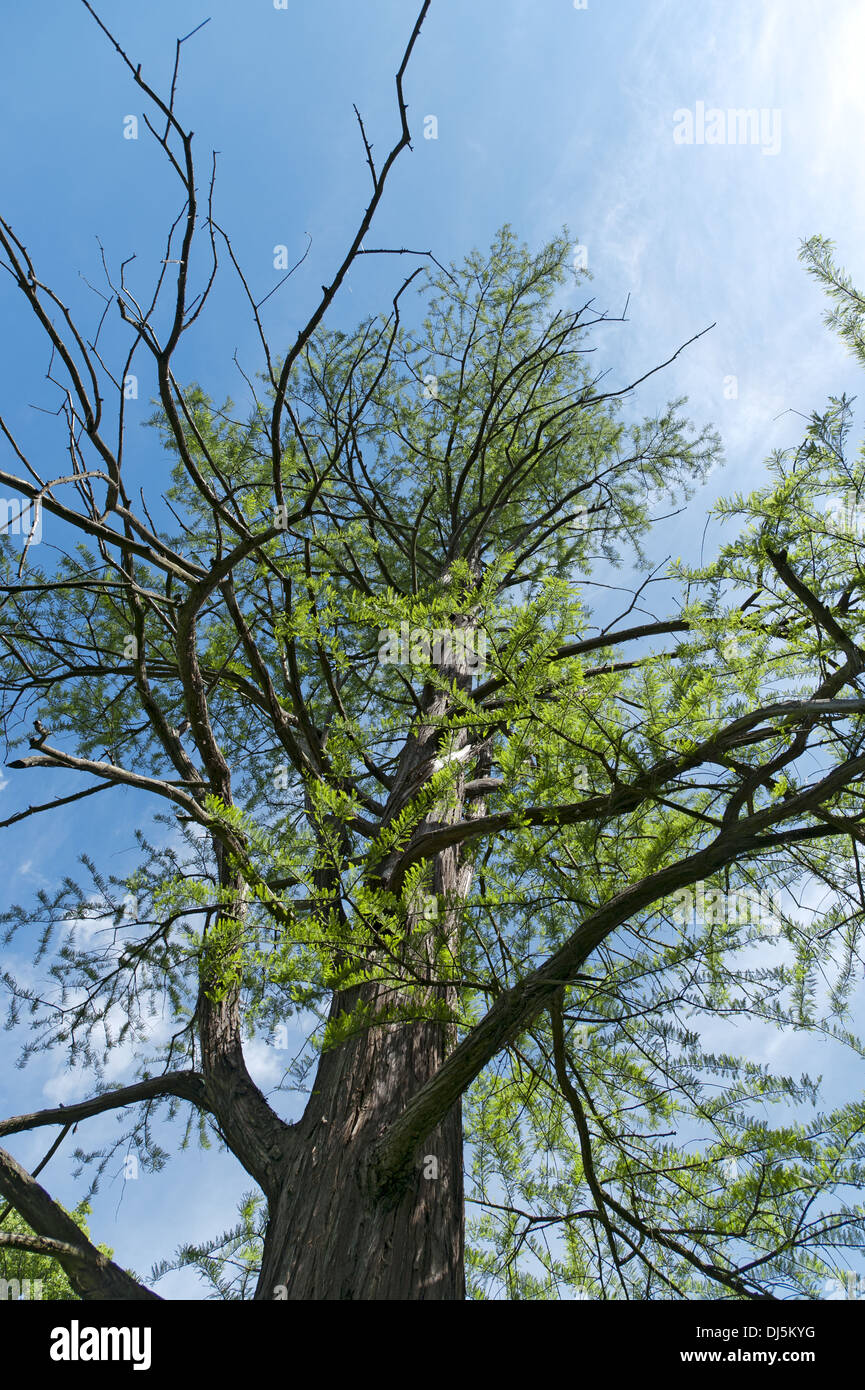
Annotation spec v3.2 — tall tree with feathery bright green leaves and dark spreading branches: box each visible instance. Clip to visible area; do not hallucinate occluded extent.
[0,0,865,1300]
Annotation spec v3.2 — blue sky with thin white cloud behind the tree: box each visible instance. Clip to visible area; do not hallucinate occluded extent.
[0,0,865,1297]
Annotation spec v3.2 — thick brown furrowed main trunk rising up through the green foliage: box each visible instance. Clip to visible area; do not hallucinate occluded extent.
[256,617,488,1301]
